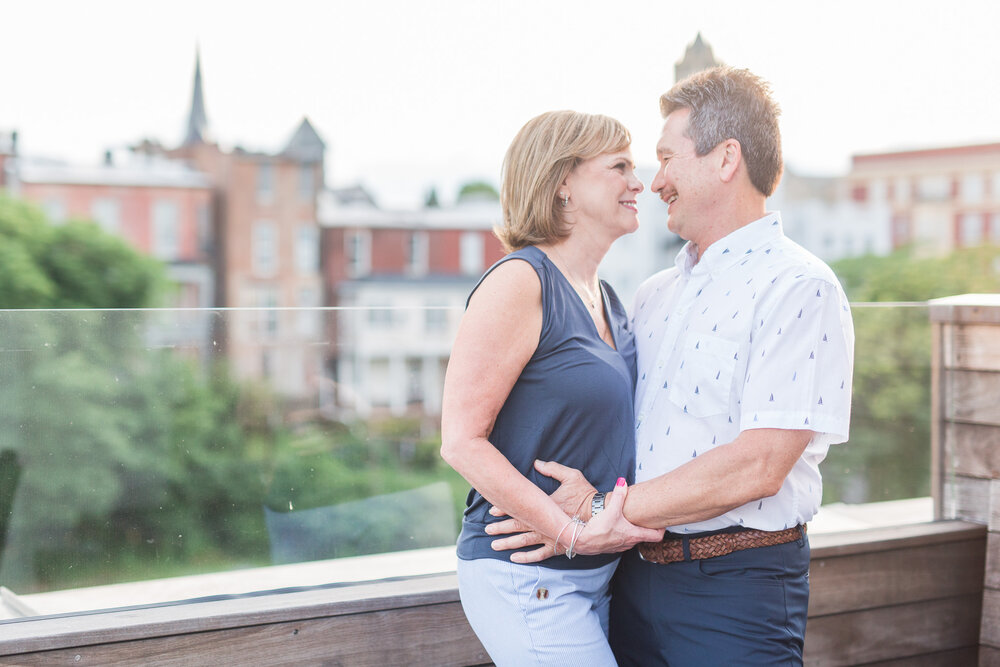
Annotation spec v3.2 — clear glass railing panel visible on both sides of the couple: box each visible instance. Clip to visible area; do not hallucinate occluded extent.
[0,304,930,618]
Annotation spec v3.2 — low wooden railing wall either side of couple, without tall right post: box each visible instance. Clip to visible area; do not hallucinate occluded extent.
[0,521,986,665]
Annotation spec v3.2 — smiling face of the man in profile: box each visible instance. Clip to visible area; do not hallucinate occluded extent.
[650,109,718,243]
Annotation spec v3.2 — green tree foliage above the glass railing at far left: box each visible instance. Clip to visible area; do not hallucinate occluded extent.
[0,195,166,308]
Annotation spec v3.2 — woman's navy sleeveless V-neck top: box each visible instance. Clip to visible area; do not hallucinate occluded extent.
[457,246,636,569]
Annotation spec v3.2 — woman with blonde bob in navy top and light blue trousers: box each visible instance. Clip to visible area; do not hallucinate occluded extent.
[441,111,662,665]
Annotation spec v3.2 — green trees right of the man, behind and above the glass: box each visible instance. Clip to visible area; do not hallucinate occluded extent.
[823,246,1000,503]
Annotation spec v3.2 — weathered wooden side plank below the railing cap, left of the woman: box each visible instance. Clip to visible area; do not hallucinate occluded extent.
[0,602,489,667]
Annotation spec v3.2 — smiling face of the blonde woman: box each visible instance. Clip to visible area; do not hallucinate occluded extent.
[564,149,642,238]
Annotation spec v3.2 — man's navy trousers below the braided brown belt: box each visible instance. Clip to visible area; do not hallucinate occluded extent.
[609,535,809,667]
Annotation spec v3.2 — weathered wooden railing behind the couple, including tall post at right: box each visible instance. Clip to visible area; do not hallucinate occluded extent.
[0,295,1000,667]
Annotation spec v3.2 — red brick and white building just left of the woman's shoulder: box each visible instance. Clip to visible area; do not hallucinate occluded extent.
[319,188,504,418]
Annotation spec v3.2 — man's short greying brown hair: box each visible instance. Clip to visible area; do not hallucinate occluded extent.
[660,66,782,197]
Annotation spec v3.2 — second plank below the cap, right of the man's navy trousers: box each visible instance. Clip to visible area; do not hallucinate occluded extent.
[804,594,982,667]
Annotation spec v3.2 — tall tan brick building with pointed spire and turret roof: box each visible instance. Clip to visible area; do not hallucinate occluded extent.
[152,51,326,407]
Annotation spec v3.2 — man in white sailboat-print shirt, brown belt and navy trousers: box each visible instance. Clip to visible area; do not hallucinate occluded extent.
[491,67,854,666]
